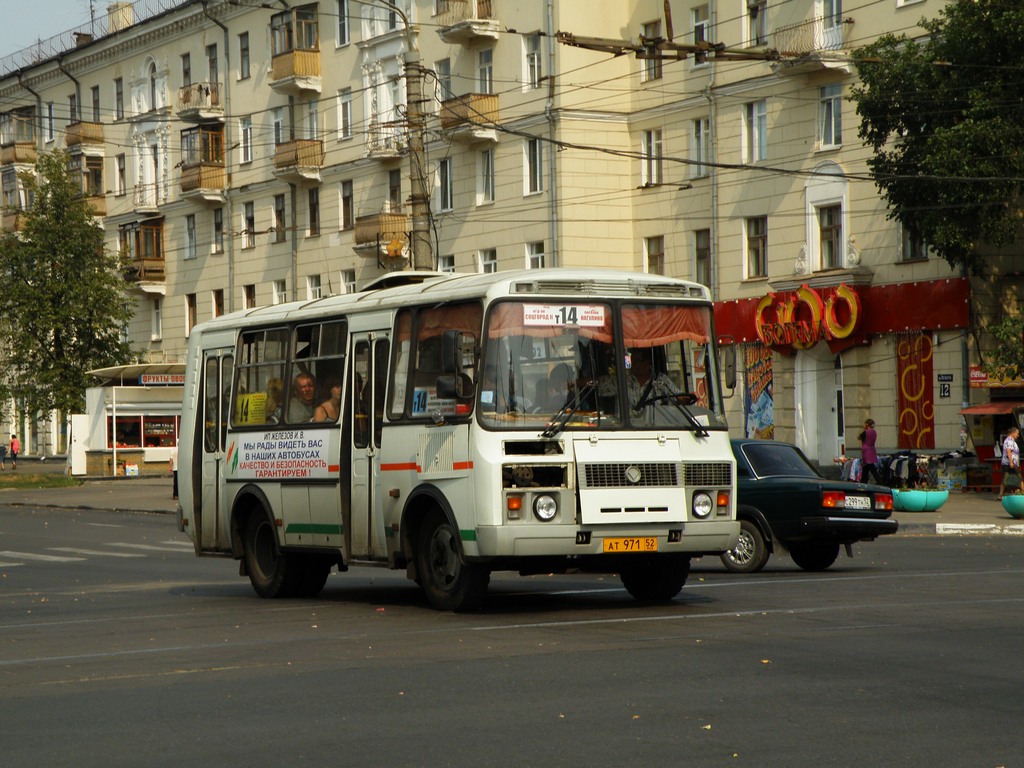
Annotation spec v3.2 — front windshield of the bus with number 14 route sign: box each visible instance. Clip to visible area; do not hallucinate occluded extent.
[477,300,726,435]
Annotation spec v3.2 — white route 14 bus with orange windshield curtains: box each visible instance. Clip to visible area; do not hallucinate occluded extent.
[178,269,738,610]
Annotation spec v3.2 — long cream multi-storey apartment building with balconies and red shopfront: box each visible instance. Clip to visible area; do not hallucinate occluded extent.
[0,0,1007,464]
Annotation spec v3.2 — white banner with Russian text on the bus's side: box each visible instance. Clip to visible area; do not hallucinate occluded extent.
[227,429,338,480]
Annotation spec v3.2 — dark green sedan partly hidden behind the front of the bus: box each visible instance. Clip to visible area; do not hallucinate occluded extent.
[722,440,899,573]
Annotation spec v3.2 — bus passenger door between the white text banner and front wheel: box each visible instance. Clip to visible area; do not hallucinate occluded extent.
[346,333,389,558]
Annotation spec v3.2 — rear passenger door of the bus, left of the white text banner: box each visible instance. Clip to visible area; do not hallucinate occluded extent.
[194,349,234,550]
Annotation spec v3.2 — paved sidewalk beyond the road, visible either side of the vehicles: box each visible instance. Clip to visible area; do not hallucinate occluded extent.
[0,477,1024,536]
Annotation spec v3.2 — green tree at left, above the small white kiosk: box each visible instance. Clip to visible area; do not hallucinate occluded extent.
[0,152,133,421]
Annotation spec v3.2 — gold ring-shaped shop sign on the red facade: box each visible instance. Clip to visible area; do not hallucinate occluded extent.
[755,283,862,349]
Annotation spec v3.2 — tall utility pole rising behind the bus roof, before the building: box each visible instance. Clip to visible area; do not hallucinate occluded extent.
[380,0,434,269]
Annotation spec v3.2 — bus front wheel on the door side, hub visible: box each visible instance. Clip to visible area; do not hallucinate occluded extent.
[416,511,490,611]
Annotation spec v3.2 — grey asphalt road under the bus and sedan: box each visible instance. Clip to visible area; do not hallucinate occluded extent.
[0,508,1024,768]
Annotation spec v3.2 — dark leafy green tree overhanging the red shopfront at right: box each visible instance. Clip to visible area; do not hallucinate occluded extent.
[853,0,1024,274]
